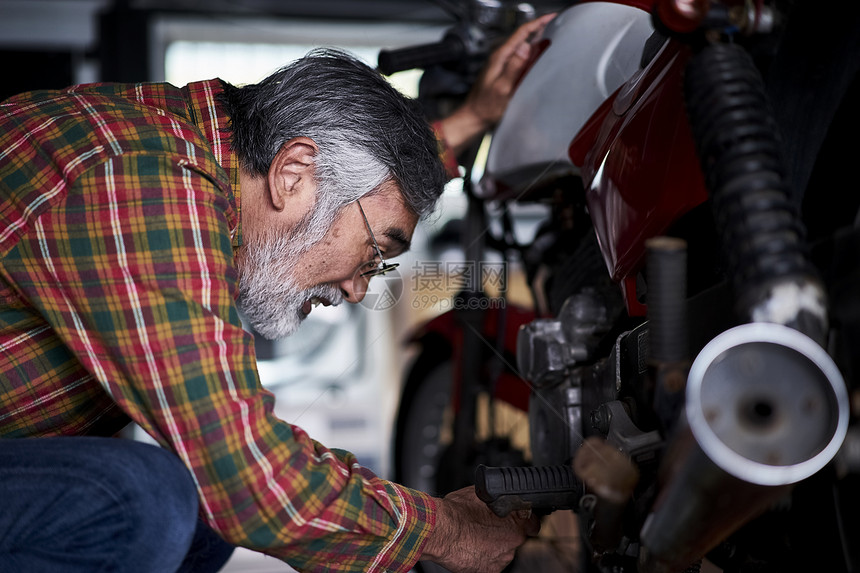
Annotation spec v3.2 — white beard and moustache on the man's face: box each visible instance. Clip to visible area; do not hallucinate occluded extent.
[236,225,343,340]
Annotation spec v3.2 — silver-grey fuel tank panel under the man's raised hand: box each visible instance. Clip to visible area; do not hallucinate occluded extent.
[476,2,654,197]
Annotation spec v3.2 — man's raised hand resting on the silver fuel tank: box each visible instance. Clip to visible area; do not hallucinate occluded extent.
[442,14,555,155]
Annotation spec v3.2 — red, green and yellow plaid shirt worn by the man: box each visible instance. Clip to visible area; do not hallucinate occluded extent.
[0,80,435,571]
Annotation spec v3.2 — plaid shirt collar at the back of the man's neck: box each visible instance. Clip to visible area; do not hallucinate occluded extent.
[182,79,242,248]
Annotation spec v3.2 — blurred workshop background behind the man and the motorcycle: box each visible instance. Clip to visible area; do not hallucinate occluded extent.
[0,0,570,572]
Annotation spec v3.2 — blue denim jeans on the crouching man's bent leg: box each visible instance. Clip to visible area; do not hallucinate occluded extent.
[0,437,233,573]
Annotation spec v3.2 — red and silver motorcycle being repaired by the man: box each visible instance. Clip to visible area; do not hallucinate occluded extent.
[380,0,860,573]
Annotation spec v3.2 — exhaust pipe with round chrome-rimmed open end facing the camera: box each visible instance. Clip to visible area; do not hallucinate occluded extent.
[640,323,849,573]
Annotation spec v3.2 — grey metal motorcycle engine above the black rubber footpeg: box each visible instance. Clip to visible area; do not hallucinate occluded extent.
[517,286,660,466]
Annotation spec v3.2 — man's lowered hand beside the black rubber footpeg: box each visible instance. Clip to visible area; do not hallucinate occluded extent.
[421,487,540,573]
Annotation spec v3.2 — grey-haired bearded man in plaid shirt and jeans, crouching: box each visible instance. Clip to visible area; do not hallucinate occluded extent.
[0,14,545,573]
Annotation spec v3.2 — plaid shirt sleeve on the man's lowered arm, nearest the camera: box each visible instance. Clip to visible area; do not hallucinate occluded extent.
[5,154,435,571]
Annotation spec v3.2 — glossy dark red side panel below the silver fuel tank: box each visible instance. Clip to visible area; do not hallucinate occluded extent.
[569,40,708,316]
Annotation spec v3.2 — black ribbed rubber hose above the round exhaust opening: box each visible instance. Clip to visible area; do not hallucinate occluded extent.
[684,44,817,312]
